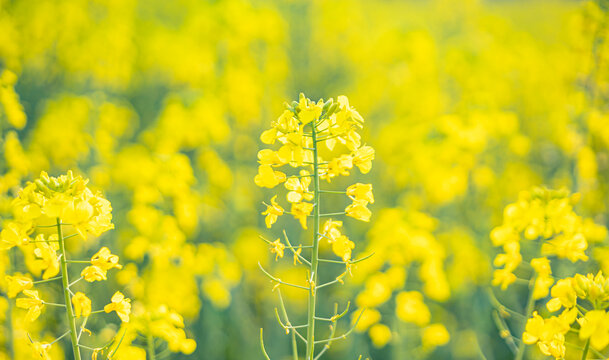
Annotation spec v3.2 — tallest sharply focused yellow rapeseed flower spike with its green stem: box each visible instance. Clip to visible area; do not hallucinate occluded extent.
[254,94,374,360]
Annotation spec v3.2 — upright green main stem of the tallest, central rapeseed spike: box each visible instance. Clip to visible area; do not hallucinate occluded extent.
[305,123,320,360]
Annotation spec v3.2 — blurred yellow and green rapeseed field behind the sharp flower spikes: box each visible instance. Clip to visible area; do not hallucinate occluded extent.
[0,0,609,360]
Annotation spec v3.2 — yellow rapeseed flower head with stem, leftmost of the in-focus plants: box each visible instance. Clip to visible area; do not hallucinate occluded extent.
[0,172,131,359]
